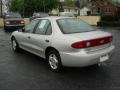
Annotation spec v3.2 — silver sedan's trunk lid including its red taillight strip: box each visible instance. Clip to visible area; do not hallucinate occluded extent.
[68,31,112,51]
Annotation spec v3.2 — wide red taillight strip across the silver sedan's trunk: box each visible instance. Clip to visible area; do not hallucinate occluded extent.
[71,36,112,49]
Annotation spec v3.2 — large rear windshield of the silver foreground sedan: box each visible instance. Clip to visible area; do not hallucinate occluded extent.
[57,18,94,34]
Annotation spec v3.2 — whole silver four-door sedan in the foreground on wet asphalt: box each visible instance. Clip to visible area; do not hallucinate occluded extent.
[11,17,114,71]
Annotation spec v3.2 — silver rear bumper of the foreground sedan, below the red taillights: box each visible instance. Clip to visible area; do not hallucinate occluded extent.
[60,46,115,67]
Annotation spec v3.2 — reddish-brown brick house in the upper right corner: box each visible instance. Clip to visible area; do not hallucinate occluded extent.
[91,0,120,16]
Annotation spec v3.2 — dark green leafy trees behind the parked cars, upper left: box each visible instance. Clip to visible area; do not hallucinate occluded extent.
[9,0,58,16]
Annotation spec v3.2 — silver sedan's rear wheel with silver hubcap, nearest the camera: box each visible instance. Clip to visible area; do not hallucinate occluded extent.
[47,50,62,72]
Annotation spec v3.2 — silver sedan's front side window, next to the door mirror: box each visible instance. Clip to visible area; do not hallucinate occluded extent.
[25,20,38,33]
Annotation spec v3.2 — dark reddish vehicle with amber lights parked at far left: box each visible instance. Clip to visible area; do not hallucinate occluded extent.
[3,12,25,31]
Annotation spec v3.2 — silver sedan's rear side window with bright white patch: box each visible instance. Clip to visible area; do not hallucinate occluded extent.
[35,20,52,35]
